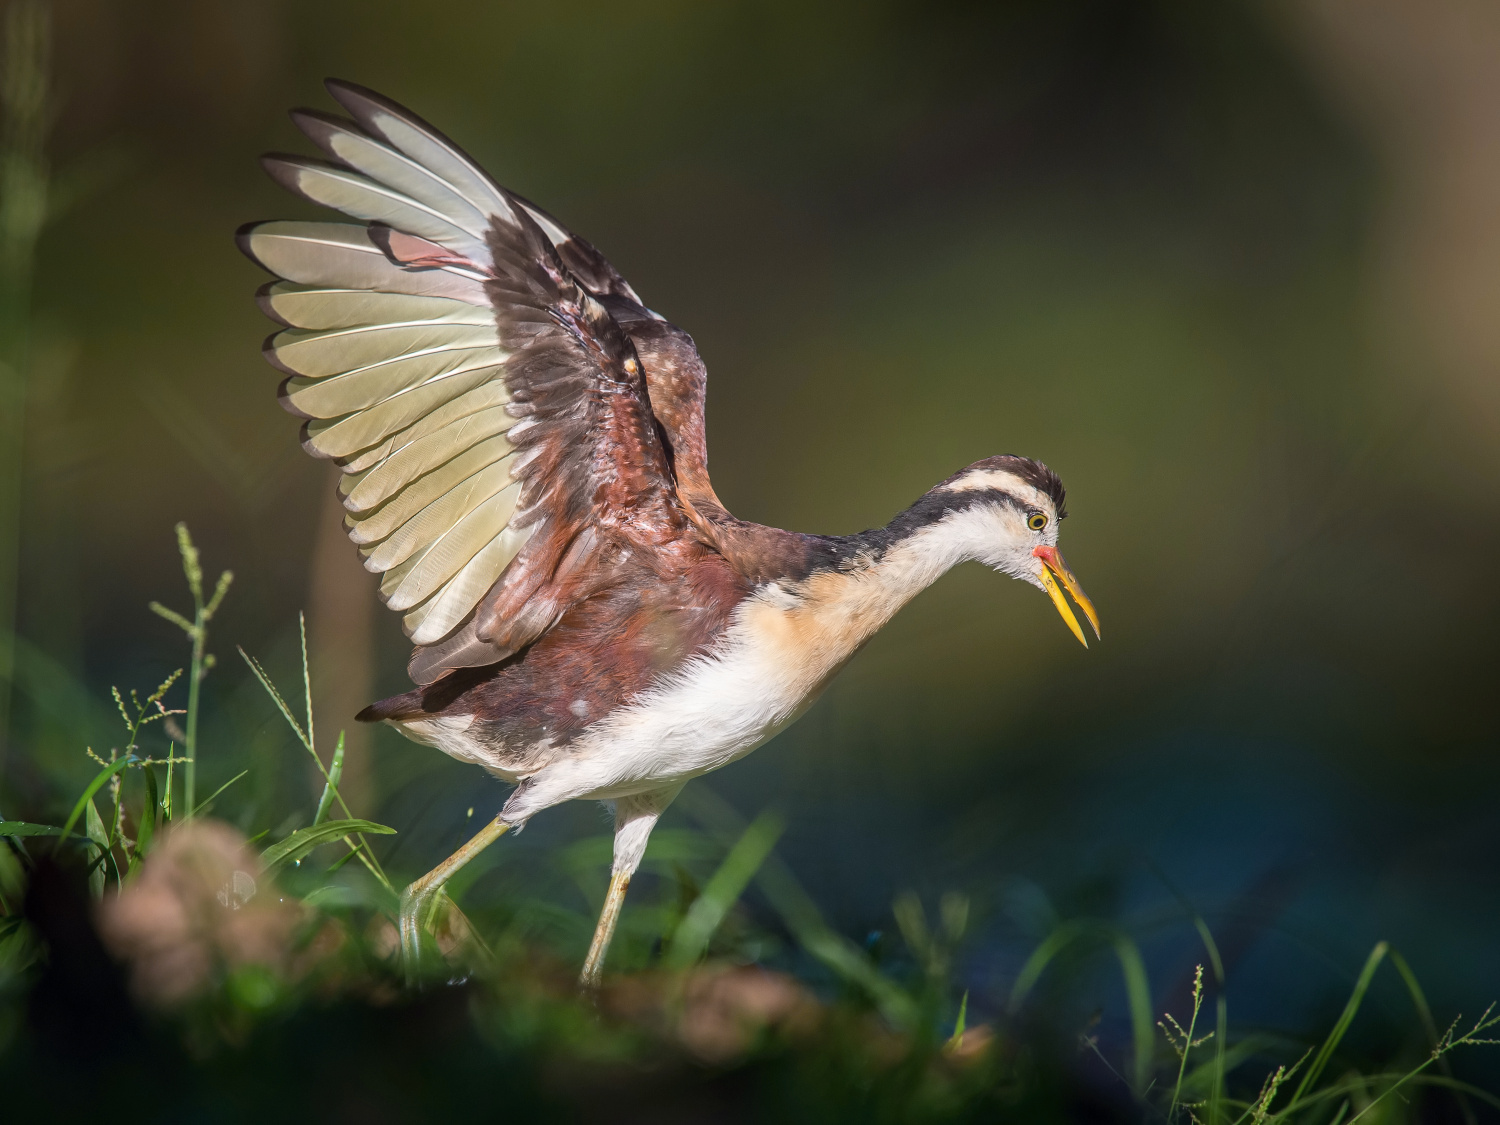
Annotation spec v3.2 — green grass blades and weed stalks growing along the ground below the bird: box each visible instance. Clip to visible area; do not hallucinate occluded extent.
[0,528,1500,1125]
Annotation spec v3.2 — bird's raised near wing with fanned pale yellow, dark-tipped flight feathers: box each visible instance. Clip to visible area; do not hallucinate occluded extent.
[240,83,701,683]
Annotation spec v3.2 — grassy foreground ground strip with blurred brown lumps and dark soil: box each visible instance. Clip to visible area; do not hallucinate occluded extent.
[0,525,1500,1125]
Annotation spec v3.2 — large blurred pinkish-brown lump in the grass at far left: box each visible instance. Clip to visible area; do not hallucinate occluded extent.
[99,821,305,1008]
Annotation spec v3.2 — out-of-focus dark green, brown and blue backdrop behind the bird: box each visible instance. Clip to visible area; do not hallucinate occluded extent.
[0,0,1500,1056]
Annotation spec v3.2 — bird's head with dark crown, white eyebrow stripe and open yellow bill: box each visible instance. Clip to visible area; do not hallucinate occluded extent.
[929,455,1100,648]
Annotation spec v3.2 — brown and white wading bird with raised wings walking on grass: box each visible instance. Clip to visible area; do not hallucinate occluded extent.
[237,80,1100,989]
